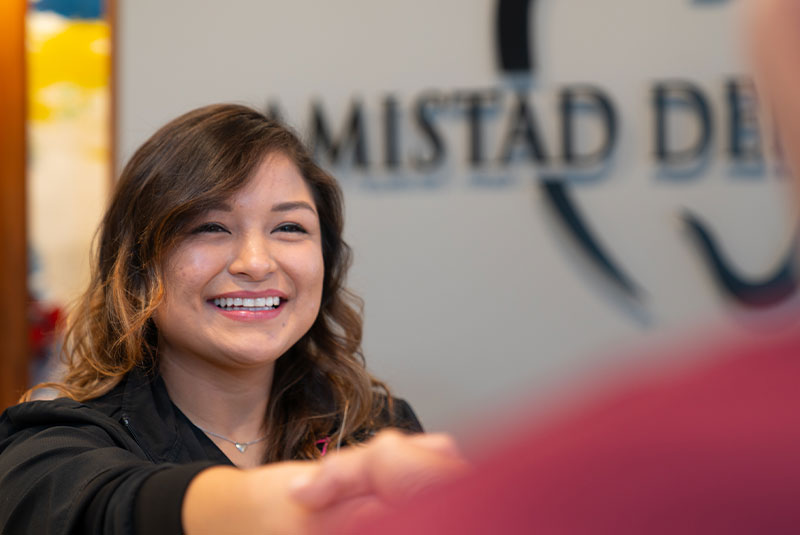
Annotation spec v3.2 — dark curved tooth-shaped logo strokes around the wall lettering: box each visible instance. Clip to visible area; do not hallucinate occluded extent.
[495,0,797,307]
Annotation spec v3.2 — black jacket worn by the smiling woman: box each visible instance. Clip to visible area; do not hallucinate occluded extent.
[0,371,421,535]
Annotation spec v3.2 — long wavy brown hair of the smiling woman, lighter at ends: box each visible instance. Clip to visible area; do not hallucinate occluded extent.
[29,104,393,462]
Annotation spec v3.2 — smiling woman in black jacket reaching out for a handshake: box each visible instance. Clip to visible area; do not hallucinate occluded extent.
[0,105,459,533]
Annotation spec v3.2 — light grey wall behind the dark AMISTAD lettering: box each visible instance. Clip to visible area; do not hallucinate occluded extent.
[117,0,794,430]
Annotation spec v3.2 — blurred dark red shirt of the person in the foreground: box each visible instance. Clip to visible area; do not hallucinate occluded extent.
[362,334,800,535]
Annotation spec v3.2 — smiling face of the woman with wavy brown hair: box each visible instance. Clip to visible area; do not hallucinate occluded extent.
[154,154,324,369]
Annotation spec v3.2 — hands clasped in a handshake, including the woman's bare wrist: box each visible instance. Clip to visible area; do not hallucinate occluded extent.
[182,430,465,535]
